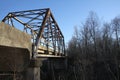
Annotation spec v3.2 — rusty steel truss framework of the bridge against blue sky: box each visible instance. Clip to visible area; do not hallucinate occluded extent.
[2,8,65,57]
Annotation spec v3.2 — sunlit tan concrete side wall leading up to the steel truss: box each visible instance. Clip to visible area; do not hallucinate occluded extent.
[0,22,32,52]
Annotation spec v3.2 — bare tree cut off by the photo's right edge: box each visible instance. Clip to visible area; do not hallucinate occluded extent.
[112,17,120,80]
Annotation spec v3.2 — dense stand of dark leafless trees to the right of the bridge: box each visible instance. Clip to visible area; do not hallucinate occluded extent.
[66,11,120,80]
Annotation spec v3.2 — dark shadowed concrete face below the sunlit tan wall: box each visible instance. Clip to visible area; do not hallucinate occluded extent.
[0,46,30,72]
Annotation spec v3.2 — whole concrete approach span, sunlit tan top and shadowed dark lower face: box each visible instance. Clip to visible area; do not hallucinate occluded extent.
[0,22,32,71]
